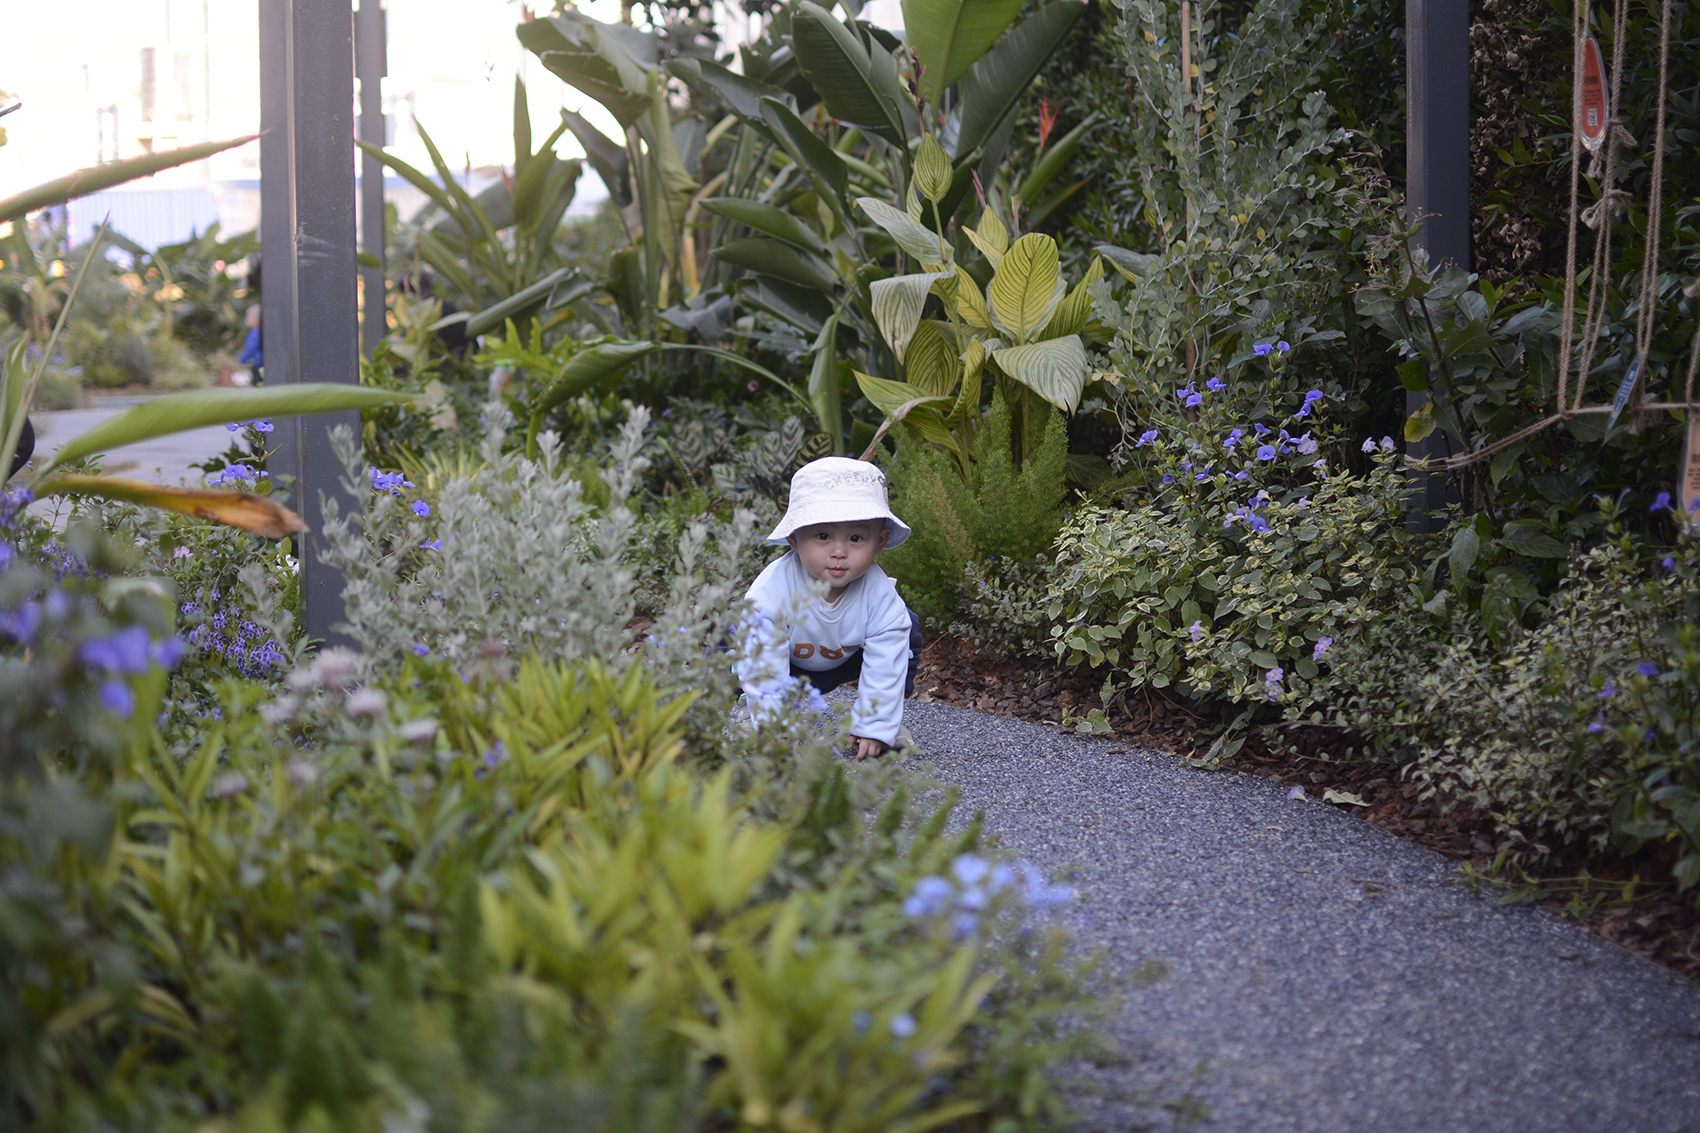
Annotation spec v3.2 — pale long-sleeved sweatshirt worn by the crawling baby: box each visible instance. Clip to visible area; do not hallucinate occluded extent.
[738,551,910,743]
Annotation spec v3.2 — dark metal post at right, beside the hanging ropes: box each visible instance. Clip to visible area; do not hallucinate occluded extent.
[1404,0,1471,532]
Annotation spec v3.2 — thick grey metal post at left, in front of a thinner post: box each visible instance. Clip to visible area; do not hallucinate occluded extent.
[260,0,360,645]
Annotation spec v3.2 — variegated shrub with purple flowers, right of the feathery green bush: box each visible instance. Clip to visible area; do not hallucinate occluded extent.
[1047,379,1413,750]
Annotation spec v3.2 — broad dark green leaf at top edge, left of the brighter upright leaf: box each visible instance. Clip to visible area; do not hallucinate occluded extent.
[791,0,918,146]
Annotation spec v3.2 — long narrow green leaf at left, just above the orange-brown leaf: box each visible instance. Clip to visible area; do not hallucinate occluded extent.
[39,381,408,476]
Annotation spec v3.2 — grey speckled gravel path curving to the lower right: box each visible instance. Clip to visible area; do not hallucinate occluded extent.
[904,703,1700,1133]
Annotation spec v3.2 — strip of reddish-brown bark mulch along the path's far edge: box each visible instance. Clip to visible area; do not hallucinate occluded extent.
[915,638,1700,978]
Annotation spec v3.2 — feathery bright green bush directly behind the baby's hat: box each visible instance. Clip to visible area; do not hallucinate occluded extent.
[881,393,1068,628]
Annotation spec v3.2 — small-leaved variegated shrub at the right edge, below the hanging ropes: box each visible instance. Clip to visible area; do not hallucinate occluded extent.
[1324,502,1700,888]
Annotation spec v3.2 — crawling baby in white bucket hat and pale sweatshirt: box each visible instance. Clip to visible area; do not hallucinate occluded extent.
[738,456,921,759]
